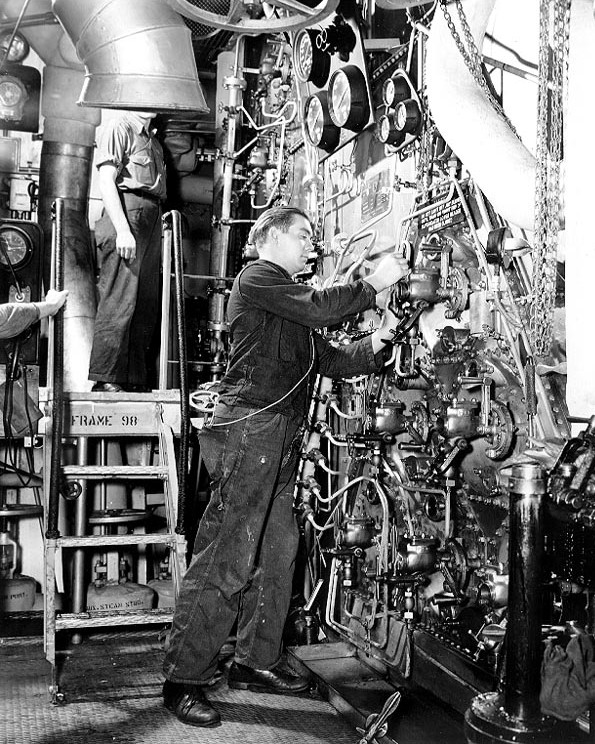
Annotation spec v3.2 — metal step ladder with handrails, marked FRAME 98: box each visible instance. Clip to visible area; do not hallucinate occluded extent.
[40,200,189,703]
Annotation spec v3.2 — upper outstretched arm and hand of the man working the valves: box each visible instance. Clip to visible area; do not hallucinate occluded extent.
[238,255,409,328]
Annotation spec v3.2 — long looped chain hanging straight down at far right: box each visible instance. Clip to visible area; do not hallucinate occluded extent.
[529,0,570,356]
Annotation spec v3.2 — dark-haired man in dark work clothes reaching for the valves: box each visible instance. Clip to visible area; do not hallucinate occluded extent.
[163,207,408,726]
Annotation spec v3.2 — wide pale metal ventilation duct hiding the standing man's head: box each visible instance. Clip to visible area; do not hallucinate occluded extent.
[52,0,209,113]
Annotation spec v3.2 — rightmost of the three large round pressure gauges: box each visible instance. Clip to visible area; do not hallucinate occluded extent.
[329,65,370,132]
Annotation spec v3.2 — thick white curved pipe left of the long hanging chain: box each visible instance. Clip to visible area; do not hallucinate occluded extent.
[426,0,536,230]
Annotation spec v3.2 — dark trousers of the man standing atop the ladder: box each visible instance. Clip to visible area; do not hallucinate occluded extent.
[89,193,161,385]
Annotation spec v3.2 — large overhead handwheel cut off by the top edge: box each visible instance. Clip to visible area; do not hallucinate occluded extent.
[167,0,339,36]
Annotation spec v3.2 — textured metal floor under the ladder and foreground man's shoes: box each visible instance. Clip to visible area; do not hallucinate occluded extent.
[0,630,359,744]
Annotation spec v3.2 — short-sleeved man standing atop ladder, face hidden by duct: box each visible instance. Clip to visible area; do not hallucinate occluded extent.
[89,111,165,392]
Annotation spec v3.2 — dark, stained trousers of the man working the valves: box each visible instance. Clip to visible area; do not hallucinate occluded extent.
[163,404,301,684]
